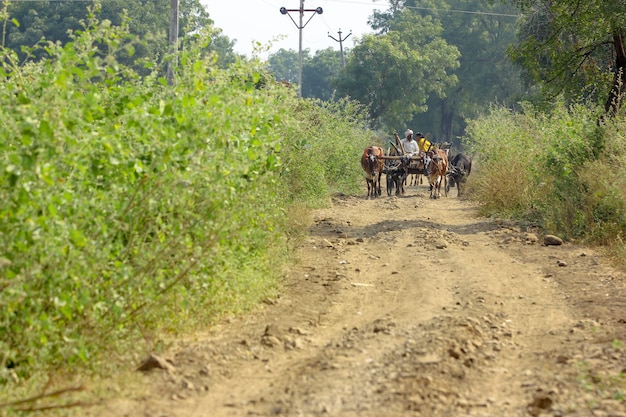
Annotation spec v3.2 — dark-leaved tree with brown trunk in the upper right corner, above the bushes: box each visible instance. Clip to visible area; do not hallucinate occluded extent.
[511,0,626,116]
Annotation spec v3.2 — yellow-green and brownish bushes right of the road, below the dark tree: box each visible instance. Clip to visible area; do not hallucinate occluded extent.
[465,101,626,246]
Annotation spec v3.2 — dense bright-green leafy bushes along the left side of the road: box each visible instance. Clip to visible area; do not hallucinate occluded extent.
[0,13,367,385]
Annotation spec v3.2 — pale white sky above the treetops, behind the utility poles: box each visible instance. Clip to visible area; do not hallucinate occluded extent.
[201,0,388,58]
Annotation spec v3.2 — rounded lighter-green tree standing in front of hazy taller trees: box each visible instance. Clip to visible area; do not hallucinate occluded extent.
[337,11,459,129]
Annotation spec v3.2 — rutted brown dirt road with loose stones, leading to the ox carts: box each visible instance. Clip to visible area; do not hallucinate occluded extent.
[91,185,626,417]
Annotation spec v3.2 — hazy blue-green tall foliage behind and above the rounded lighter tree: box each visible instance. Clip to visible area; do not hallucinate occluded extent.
[371,0,522,141]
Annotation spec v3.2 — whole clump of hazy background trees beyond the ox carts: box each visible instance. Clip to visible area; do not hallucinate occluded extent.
[269,0,521,140]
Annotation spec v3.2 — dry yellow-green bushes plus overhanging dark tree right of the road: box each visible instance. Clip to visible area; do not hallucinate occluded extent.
[463,0,626,267]
